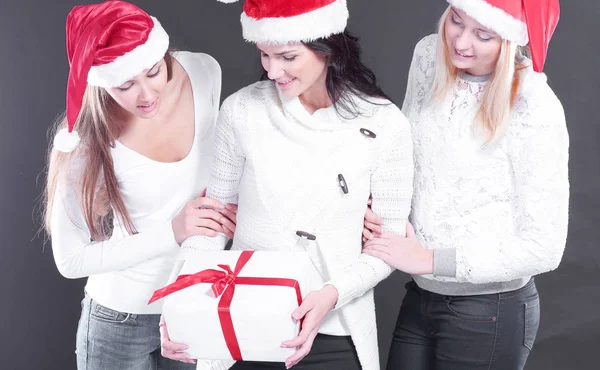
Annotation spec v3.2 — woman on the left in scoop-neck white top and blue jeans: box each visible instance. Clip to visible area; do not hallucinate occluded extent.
[46,1,235,370]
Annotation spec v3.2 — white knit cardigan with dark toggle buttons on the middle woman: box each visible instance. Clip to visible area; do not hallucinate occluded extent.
[181,81,413,370]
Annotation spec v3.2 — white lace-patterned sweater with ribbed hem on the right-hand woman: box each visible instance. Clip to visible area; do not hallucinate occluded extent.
[402,35,569,295]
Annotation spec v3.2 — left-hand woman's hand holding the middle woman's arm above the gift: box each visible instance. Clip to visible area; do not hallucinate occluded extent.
[171,189,237,244]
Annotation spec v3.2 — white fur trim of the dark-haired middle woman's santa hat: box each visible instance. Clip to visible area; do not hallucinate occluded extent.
[241,0,349,44]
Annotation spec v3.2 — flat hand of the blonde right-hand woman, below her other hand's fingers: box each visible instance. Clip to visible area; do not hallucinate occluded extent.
[363,223,433,275]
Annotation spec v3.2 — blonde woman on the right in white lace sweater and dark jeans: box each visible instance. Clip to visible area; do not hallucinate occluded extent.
[364,0,569,370]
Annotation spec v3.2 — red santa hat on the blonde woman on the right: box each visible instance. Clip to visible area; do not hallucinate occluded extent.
[447,0,560,72]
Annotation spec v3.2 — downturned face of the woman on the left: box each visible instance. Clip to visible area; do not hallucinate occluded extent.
[106,58,168,119]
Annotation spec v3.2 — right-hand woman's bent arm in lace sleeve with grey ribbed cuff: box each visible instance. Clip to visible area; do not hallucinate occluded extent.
[434,96,569,283]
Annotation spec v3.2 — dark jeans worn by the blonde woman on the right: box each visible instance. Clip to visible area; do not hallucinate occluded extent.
[387,278,540,370]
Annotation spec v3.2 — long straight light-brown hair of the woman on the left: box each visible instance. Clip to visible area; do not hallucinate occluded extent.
[43,51,173,241]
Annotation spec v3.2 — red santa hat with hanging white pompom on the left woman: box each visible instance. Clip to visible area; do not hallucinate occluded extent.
[54,1,169,152]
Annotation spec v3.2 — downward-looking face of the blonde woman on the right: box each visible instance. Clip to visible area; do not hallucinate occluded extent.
[444,8,502,76]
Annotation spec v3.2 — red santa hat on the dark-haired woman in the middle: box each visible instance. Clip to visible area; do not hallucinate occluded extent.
[218,0,348,44]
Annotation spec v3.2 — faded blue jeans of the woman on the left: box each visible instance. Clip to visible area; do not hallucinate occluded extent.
[75,294,196,370]
